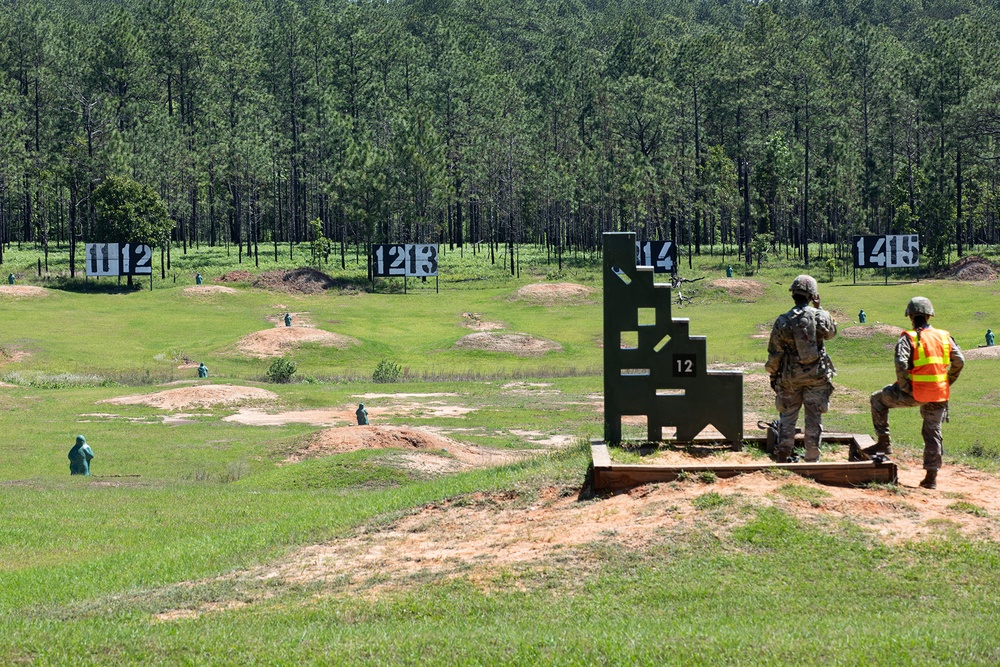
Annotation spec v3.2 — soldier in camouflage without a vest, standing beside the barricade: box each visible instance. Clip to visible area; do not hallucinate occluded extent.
[765,275,837,463]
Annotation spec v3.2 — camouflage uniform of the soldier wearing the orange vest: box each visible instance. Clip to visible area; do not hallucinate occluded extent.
[871,325,965,470]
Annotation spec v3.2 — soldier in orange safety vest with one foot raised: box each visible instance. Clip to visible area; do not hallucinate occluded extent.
[870,296,965,489]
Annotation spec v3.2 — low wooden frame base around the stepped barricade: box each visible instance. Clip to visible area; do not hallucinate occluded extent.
[590,433,897,493]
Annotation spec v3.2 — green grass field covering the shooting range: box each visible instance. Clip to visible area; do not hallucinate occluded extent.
[0,247,1000,665]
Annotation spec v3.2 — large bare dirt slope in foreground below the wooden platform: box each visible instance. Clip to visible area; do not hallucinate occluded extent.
[150,461,1000,620]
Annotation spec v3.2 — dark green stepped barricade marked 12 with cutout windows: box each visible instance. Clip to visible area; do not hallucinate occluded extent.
[604,232,743,444]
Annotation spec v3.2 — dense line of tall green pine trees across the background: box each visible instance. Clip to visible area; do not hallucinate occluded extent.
[0,0,1000,270]
